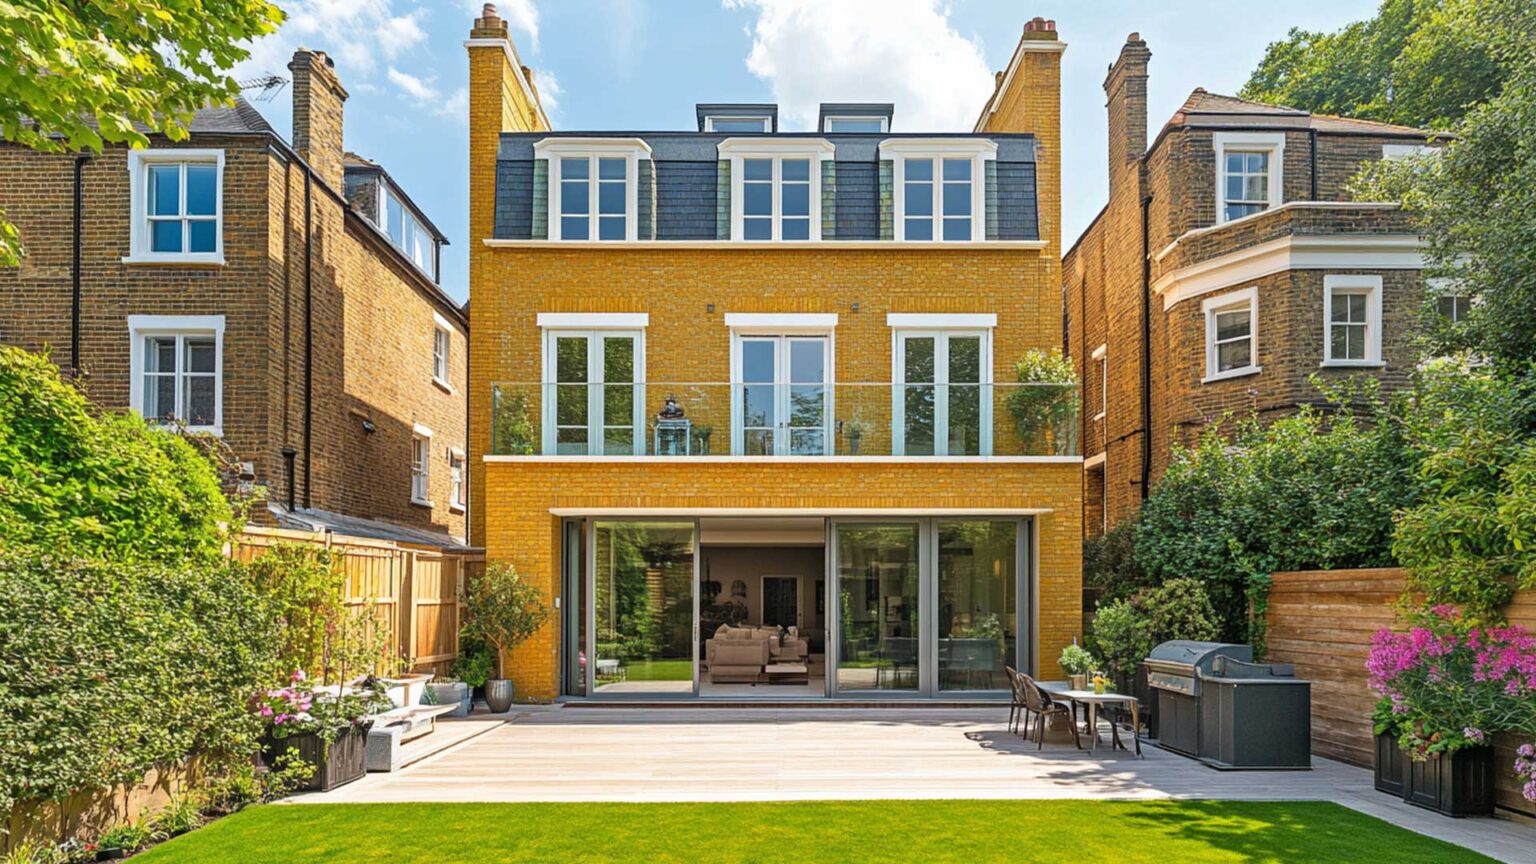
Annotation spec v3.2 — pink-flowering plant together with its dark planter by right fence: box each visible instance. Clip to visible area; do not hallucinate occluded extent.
[1366,606,1536,816]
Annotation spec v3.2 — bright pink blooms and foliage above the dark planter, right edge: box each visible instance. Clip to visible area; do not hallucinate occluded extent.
[1366,606,1536,799]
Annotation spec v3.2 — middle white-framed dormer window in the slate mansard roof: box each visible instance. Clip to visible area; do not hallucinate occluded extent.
[719,138,833,243]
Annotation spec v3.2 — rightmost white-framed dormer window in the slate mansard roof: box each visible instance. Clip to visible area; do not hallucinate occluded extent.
[880,140,997,243]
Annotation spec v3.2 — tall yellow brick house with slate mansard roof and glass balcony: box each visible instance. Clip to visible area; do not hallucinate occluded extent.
[465,9,1083,700]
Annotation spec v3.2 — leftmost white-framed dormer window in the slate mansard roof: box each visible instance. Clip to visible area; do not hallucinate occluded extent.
[533,138,650,243]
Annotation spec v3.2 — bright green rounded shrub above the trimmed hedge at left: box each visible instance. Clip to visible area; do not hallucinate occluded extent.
[0,346,233,561]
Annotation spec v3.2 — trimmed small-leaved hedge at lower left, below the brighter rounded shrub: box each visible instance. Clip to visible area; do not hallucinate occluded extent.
[0,552,278,810]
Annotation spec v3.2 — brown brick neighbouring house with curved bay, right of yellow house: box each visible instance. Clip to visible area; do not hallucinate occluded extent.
[1061,34,1443,535]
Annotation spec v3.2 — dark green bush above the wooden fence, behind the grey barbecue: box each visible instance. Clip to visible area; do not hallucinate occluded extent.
[1135,384,1413,641]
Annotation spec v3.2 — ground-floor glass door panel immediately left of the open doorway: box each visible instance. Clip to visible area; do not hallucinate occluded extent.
[587,520,697,695]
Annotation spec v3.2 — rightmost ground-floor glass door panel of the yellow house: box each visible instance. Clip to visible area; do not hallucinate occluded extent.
[935,520,1020,690]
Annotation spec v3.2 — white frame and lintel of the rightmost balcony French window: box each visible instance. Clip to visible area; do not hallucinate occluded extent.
[886,312,997,458]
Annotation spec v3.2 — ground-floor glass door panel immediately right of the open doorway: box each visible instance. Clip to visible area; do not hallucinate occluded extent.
[833,521,923,693]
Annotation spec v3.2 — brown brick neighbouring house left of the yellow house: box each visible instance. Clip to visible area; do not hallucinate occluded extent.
[0,49,468,546]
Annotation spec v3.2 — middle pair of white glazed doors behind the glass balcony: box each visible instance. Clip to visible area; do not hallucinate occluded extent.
[731,335,833,457]
